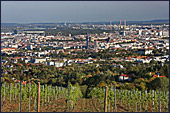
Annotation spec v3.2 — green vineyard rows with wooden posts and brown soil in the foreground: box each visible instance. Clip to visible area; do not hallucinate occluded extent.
[1,83,169,112]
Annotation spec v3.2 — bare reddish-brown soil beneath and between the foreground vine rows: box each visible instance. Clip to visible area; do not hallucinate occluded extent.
[1,98,169,112]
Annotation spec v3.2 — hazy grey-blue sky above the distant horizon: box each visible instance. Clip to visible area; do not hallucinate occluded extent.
[1,1,169,23]
